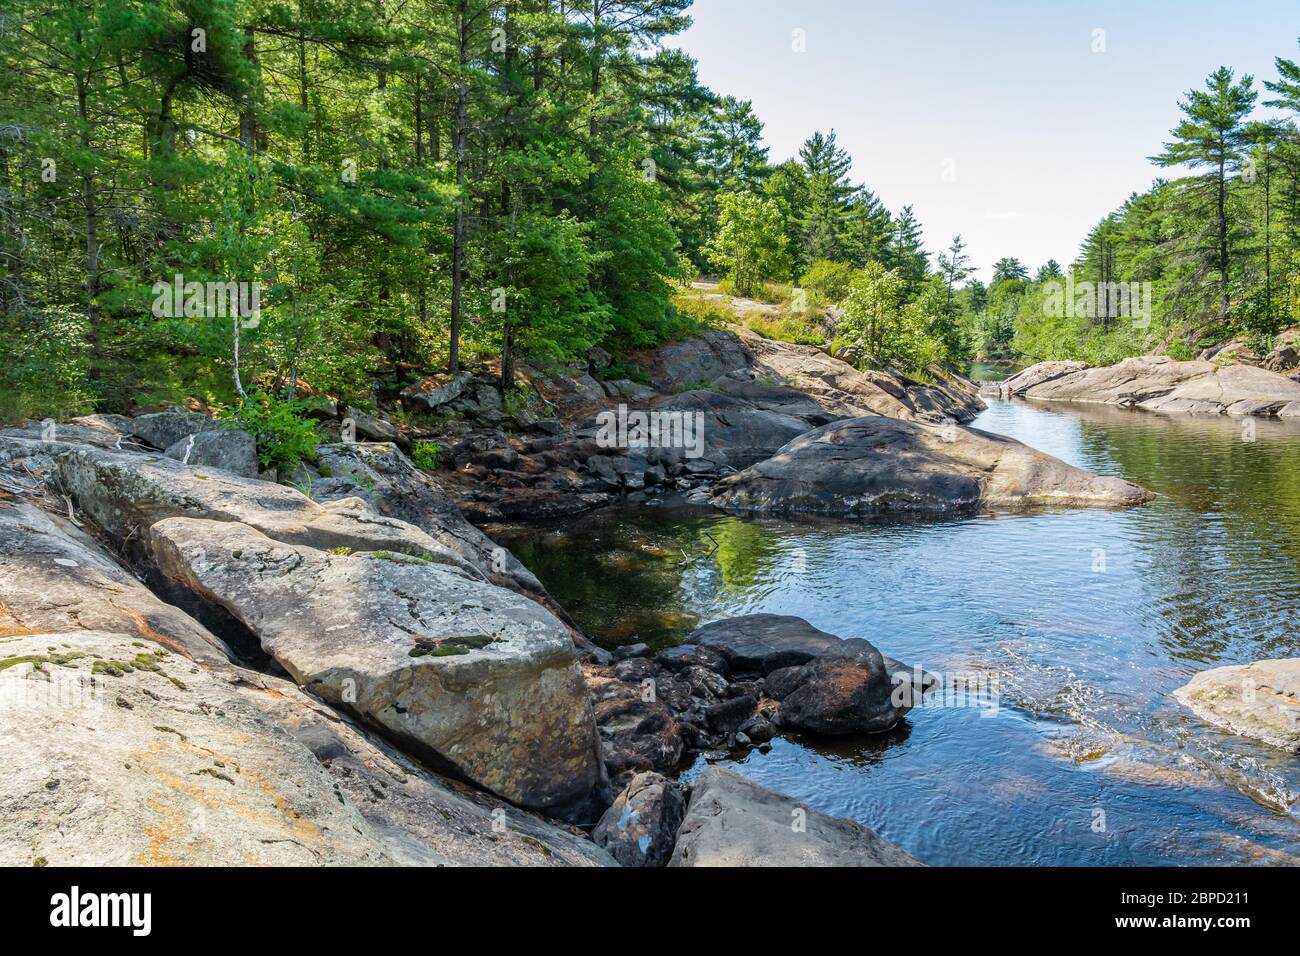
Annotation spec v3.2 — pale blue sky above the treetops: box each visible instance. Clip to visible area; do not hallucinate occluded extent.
[673,0,1300,280]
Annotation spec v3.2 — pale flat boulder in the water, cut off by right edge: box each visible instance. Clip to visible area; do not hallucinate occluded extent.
[1174,658,1300,754]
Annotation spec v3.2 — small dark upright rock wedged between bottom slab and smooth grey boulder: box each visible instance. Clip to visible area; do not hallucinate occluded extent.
[592,773,686,866]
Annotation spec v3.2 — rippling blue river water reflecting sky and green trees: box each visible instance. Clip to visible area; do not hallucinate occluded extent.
[488,401,1300,865]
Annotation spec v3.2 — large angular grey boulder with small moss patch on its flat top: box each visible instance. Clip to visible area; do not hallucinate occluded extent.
[150,518,607,819]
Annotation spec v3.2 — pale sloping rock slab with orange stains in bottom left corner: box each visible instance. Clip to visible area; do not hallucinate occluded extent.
[0,631,614,866]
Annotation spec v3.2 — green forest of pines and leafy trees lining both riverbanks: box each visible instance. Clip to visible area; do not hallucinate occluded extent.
[0,0,1300,431]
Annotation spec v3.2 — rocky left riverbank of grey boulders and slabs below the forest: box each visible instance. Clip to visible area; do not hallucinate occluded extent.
[0,332,1289,866]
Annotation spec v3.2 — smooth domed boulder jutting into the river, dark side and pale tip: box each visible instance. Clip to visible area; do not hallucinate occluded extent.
[712,416,1153,515]
